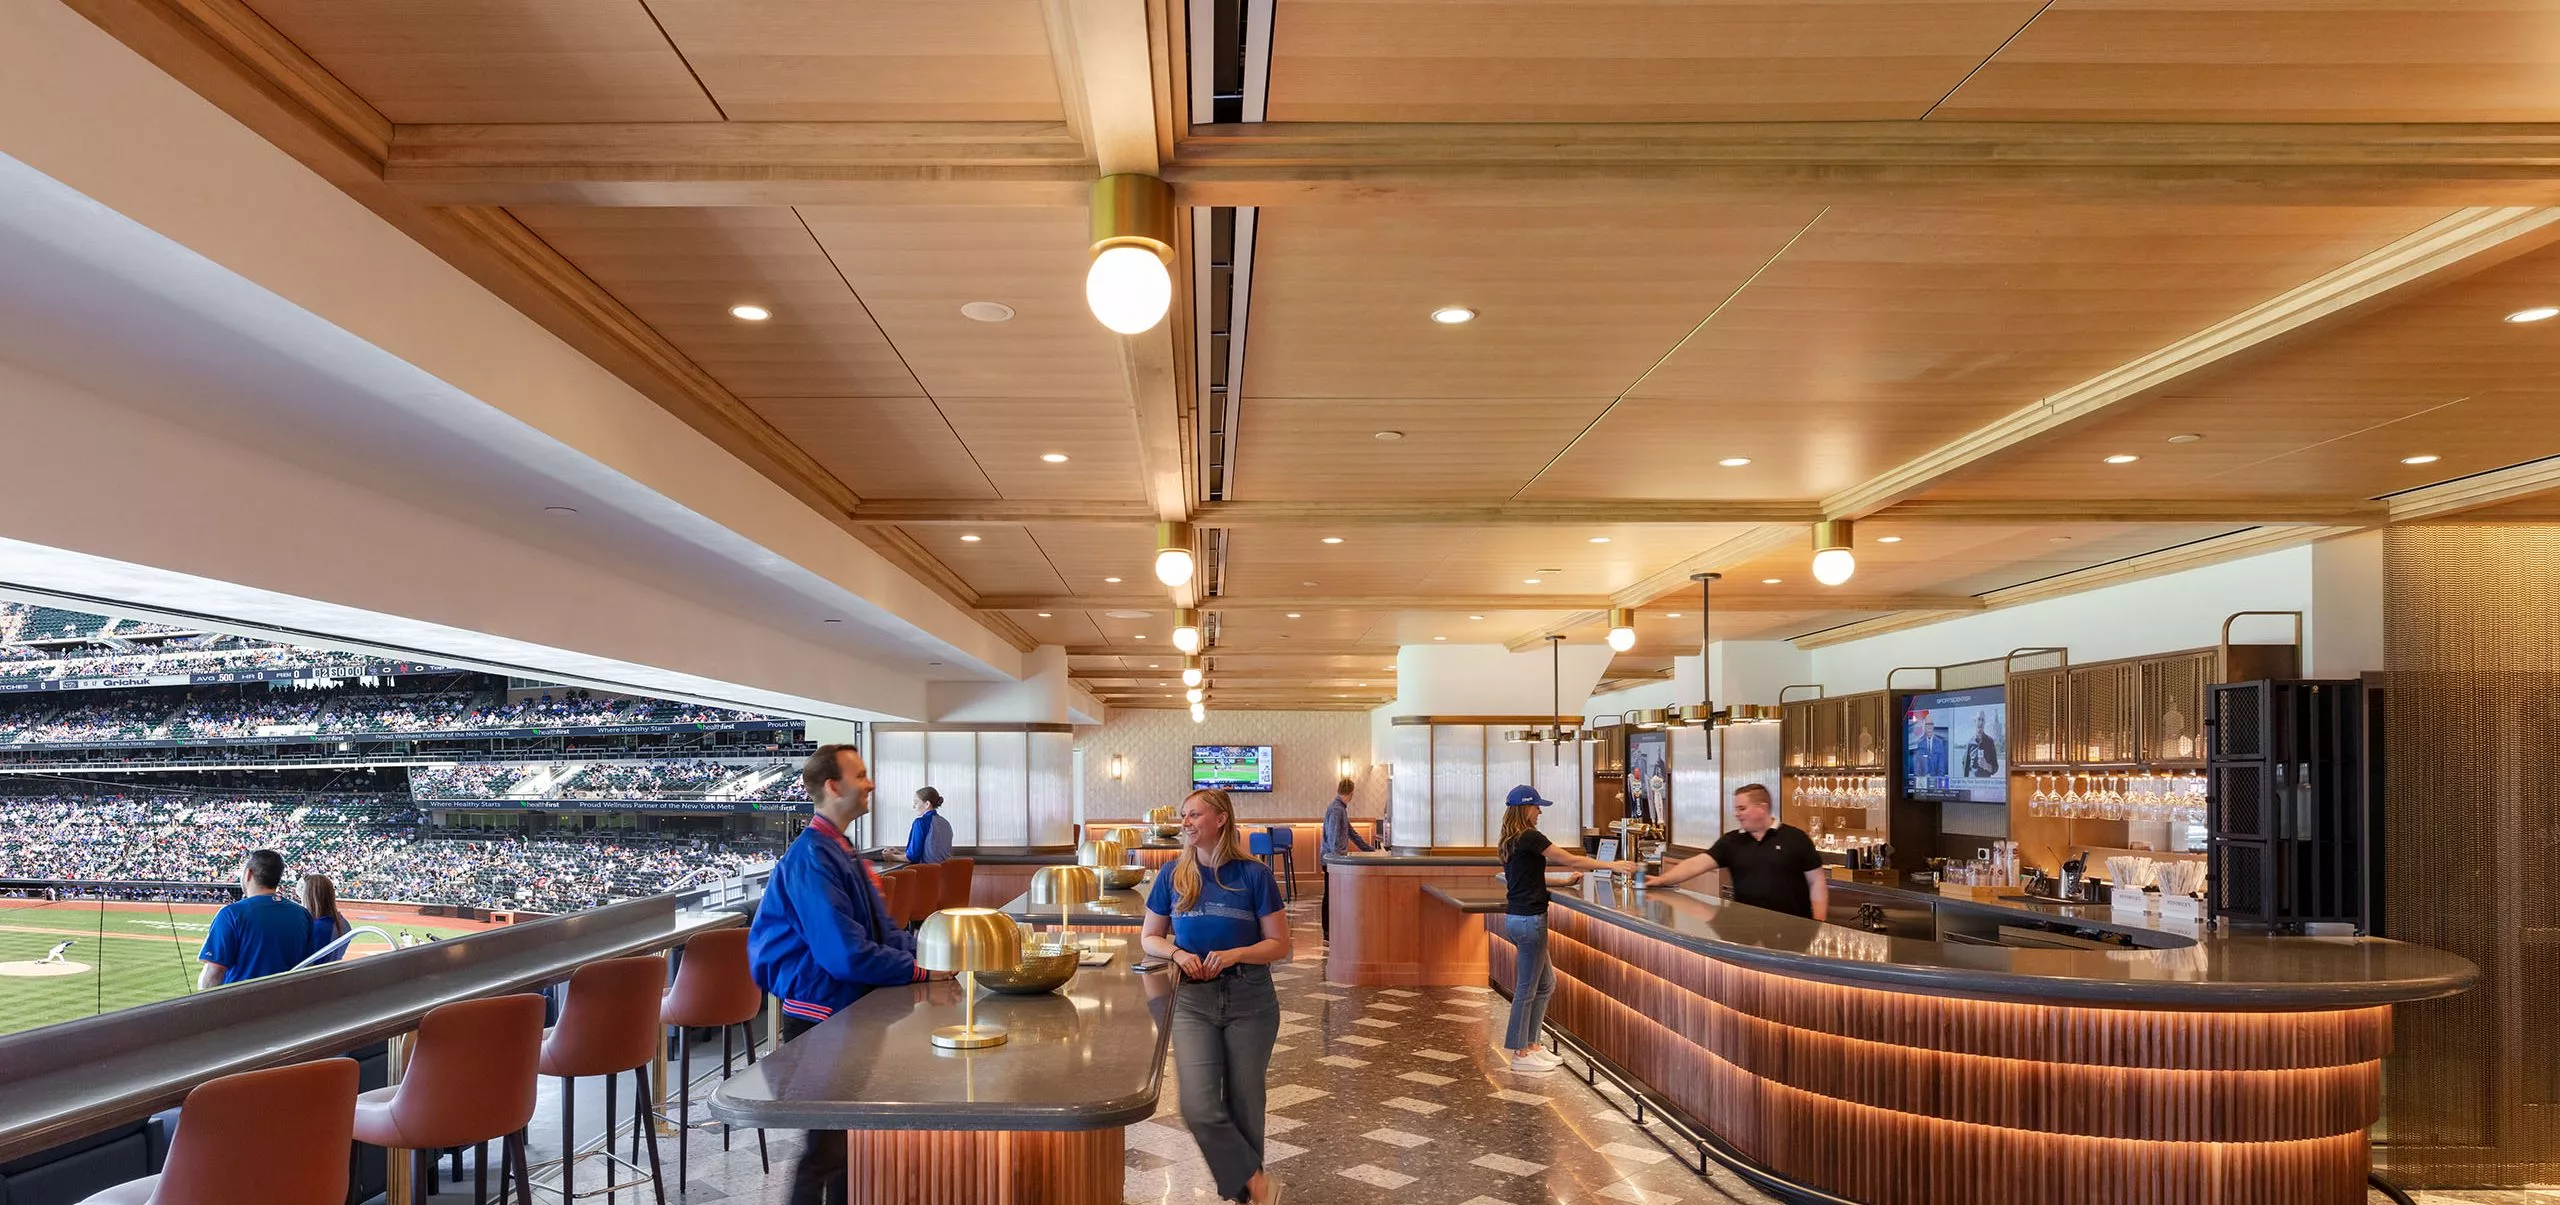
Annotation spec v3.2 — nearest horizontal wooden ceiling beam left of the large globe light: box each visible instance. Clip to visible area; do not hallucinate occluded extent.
[381,120,1098,205]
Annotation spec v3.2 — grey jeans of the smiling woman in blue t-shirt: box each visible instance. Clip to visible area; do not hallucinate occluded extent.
[1172,965,1280,1200]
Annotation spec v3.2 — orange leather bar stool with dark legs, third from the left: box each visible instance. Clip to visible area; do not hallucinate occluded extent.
[540,954,666,1205]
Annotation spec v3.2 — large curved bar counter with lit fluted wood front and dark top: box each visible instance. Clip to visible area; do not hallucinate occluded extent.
[1434,880,2478,1205]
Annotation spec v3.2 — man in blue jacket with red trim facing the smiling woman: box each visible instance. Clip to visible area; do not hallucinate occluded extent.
[748,744,937,1205]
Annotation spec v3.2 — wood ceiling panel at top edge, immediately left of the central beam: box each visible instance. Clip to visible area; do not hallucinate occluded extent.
[650,0,1065,120]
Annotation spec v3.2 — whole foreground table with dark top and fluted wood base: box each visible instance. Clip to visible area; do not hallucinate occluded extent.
[712,954,1172,1205]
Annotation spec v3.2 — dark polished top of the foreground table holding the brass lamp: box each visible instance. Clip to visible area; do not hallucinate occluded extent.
[712,952,1172,1131]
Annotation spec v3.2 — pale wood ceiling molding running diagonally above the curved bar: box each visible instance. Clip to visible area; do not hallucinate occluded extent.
[1823,207,2560,519]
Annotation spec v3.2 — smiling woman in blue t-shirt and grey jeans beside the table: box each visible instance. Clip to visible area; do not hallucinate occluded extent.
[1139,791,1288,1205]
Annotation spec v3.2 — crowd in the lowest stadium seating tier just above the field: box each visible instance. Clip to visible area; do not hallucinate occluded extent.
[0,796,781,913]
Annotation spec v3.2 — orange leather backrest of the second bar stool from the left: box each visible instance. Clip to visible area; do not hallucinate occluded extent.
[389,993,545,1156]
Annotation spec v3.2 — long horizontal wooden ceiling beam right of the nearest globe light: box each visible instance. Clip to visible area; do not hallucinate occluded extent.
[1165,120,2560,207]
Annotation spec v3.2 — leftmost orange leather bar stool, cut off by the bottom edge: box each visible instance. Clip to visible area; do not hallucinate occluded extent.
[82,1059,356,1205]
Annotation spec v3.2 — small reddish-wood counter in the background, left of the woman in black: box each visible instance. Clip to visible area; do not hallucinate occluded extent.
[1324,852,1503,988]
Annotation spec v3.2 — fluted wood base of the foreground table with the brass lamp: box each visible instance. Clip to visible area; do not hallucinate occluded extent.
[845,1126,1129,1205]
